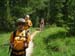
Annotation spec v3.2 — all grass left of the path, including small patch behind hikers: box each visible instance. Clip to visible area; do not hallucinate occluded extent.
[0,28,36,56]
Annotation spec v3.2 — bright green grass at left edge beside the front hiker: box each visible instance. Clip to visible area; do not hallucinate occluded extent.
[0,33,10,56]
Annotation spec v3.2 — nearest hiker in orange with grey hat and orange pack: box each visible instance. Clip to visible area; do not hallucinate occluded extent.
[10,18,30,56]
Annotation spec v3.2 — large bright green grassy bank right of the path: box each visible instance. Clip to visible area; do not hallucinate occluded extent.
[32,27,75,56]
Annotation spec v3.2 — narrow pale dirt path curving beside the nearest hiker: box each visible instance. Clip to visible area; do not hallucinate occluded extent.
[26,31,40,56]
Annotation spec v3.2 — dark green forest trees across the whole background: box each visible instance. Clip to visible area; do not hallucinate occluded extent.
[0,0,75,35]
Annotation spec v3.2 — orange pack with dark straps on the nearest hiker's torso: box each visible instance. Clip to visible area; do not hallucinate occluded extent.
[12,31,28,50]
